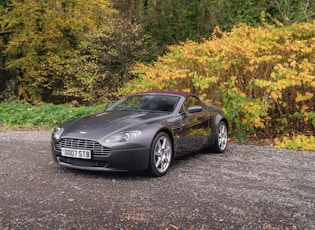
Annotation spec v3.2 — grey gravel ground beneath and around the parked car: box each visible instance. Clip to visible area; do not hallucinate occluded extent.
[0,131,315,230]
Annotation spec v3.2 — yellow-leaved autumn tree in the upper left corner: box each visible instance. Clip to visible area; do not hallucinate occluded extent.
[0,0,112,103]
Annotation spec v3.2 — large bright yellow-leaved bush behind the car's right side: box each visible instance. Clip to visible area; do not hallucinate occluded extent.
[120,22,315,149]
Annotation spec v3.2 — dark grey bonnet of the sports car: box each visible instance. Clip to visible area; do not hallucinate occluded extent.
[62,111,168,140]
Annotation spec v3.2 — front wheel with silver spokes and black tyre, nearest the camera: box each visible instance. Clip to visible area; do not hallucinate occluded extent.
[149,132,173,177]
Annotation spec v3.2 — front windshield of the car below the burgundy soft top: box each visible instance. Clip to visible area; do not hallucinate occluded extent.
[106,94,180,112]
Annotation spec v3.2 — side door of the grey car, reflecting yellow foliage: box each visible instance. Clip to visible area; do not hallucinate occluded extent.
[175,96,211,155]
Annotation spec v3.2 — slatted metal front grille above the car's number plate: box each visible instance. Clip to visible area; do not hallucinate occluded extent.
[55,138,110,156]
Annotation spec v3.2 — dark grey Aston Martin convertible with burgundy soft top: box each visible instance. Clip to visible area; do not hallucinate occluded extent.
[51,91,228,176]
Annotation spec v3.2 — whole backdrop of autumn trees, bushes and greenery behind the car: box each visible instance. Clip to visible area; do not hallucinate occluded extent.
[0,0,315,150]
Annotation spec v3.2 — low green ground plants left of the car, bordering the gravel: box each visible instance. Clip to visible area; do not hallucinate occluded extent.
[0,102,105,130]
